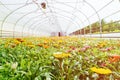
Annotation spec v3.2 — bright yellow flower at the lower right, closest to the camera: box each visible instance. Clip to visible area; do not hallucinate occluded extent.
[90,67,112,74]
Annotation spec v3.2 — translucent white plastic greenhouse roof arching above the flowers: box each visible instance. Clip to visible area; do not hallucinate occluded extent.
[0,0,120,36]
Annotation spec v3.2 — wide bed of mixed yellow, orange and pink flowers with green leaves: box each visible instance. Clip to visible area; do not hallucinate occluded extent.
[0,37,120,80]
